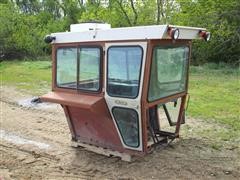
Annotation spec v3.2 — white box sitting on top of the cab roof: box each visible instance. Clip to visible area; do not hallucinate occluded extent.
[70,23,111,32]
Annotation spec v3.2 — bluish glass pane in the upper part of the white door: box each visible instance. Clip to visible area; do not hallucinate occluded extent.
[107,46,142,98]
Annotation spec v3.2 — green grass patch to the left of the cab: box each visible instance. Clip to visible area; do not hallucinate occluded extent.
[0,61,52,95]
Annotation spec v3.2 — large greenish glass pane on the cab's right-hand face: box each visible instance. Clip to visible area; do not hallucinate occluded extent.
[148,46,189,101]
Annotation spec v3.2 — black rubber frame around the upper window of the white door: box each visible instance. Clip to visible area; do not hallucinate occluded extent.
[106,44,144,99]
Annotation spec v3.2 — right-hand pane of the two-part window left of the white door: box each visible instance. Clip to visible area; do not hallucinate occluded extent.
[78,48,100,91]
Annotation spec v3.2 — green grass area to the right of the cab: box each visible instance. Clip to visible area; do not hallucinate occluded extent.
[188,64,240,140]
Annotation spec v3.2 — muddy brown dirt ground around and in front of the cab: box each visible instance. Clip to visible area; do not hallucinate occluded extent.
[0,87,240,180]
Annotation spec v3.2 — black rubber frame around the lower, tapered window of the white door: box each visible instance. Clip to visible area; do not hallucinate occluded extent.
[111,106,141,148]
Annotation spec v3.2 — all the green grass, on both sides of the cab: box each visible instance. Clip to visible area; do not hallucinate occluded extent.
[0,61,240,140]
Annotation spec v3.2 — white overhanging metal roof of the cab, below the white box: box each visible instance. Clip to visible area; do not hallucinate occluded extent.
[51,25,206,43]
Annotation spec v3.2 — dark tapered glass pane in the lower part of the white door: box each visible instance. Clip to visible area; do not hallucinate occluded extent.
[113,107,139,147]
